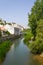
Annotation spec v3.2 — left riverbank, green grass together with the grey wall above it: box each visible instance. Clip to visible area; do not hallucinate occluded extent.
[0,35,21,64]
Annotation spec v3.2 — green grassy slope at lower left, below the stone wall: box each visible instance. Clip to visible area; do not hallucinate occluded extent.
[0,40,12,63]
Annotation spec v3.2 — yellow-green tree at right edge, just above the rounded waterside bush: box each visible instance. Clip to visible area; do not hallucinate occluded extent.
[36,19,43,43]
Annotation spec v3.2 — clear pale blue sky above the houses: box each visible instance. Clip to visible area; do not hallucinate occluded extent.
[0,0,35,27]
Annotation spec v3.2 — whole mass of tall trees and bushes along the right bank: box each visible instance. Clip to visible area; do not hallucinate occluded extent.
[25,0,43,54]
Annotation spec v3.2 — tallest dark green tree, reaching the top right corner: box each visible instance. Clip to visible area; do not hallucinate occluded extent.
[28,0,43,39]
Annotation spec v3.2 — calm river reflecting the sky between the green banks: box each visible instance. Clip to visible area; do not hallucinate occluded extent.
[2,38,43,65]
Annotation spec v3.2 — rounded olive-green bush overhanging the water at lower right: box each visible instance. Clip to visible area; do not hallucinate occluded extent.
[29,39,43,54]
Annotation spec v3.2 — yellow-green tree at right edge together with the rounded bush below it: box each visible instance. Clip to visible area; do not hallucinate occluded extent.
[29,19,43,54]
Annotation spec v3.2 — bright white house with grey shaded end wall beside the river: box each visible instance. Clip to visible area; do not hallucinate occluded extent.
[4,24,20,35]
